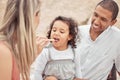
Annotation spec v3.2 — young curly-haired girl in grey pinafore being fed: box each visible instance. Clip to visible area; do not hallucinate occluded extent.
[31,16,78,80]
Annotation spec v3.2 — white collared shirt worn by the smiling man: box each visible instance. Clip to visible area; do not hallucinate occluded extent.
[75,25,120,80]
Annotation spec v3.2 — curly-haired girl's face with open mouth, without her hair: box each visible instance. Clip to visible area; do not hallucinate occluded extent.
[50,20,71,50]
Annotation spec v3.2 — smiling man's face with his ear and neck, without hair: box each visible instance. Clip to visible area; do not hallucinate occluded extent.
[90,5,116,40]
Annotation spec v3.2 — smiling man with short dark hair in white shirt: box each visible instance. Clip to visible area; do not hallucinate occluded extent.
[75,0,120,80]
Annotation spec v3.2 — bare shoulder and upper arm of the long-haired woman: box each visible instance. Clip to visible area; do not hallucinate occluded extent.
[0,41,12,80]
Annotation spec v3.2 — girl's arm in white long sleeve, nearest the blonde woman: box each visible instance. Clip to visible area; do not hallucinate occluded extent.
[30,48,49,80]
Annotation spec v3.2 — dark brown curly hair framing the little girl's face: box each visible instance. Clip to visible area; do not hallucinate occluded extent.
[47,16,78,48]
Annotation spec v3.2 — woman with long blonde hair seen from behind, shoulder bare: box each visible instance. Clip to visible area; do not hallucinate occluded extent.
[0,0,40,80]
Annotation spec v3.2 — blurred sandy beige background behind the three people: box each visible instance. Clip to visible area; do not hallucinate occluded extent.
[0,0,120,80]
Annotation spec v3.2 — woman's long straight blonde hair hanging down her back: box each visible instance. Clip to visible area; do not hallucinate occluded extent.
[0,0,40,80]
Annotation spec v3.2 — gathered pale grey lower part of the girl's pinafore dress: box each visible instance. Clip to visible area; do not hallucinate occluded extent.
[43,59,75,80]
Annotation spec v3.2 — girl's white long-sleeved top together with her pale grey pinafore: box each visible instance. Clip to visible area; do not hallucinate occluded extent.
[30,46,75,80]
